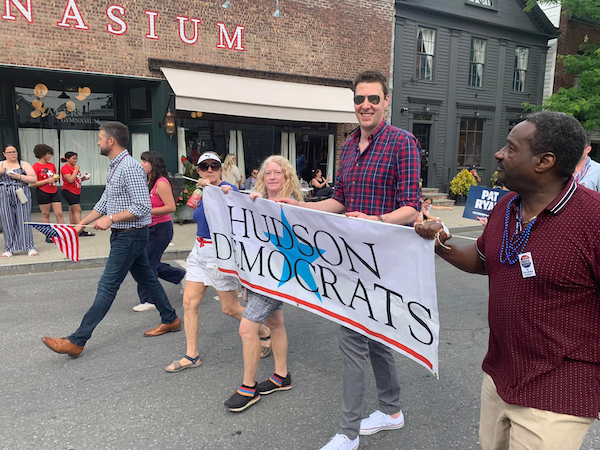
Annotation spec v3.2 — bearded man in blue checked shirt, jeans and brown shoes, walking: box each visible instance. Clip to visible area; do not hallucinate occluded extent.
[42,122,181,357]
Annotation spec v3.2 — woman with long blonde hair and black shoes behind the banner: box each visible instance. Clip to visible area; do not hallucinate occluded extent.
[223,155,303,412]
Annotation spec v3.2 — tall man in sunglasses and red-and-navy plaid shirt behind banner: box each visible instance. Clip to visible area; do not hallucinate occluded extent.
[280,71,421,450]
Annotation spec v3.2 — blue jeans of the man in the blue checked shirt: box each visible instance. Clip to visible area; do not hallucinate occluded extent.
[67,227,177,345]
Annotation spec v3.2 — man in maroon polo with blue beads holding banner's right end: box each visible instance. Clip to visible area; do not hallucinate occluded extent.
[415,111,600,450]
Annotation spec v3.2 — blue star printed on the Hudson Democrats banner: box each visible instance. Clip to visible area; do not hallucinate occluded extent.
[265,209,325,302]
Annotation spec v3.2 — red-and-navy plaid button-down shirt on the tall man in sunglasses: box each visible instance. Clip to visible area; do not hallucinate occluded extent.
[333,120,421,215]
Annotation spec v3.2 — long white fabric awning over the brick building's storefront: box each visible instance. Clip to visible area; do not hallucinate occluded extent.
[161,67,357,123]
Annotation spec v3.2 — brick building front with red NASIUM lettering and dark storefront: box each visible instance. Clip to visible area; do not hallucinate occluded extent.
[0,0,394,206]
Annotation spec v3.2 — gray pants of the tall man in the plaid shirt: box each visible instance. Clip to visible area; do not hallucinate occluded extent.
[337,327,402,440]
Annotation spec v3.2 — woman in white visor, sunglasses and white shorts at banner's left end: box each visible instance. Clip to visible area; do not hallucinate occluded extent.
[166,152,270,372]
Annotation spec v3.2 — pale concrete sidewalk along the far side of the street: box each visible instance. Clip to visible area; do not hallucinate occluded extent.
[0,206,483,276]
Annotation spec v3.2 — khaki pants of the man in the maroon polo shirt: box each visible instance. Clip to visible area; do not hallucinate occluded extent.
[479,374,594,450]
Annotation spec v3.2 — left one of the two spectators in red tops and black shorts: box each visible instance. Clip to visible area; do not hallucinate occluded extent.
[31,144,65,236]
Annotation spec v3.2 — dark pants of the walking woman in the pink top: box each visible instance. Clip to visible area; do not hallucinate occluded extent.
[138,222,185,303]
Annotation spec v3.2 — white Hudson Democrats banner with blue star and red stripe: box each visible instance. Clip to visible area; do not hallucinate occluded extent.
[203,187,439,377]
